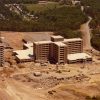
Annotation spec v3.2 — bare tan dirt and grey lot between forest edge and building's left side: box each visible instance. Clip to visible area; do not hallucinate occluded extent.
[1,31,54,50]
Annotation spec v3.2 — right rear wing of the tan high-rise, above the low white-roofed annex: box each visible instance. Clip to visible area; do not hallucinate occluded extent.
[63,38,83,54]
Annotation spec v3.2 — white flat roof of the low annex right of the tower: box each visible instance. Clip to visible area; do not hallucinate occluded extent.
[67,53,92,61]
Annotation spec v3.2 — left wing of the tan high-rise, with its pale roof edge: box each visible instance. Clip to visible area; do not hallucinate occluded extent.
[34,41,52,62]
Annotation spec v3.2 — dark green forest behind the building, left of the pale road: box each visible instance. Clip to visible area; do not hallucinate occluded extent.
[0,1,87,38]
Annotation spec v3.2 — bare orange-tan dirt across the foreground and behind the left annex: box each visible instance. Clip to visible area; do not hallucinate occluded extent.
[0,32,100,100]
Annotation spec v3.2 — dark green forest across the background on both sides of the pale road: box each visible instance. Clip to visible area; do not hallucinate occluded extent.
[0,0,100,50]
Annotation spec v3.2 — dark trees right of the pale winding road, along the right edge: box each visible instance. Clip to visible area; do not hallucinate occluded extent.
[81,0,100,51]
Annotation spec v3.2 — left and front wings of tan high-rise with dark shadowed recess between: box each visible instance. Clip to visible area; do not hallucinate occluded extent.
[34,41,67,64]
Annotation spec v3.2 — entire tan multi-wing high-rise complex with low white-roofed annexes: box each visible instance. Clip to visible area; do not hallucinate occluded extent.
[14,35,92,64]
